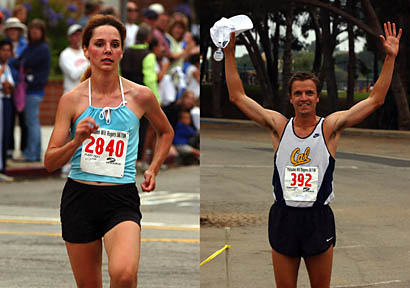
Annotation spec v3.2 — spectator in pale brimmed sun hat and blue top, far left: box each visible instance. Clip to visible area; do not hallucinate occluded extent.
[4,17,27,158]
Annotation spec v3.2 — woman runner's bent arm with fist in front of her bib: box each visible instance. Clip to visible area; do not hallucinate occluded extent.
[44,94,98,172]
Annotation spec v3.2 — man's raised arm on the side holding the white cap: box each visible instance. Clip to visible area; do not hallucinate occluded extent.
[224,32,287,134]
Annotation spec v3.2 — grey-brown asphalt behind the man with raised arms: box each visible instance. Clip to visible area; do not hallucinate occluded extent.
[200,123,410,288]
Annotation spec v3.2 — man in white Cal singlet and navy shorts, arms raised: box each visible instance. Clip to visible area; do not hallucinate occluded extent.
[224,22,402,287]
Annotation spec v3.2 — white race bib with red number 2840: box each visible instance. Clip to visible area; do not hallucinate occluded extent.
[80,128,129,177]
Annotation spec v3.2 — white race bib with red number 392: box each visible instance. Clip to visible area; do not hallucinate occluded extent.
[283,166,319,201]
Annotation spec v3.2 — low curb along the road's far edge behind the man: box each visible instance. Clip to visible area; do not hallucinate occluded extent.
[201,118,410,139]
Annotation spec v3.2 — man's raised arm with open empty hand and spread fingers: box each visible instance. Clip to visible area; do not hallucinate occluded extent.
[326,22,402,134]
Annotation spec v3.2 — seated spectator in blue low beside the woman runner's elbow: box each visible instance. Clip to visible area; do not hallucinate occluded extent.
[173,111,200,160]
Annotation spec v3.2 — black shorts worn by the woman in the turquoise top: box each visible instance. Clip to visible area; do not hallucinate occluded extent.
[60,178,142,243]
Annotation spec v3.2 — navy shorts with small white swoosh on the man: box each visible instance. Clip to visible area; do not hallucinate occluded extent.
[268,203,336,258]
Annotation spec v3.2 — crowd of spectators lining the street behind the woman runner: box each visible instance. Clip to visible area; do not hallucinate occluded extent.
[0,0,200,181]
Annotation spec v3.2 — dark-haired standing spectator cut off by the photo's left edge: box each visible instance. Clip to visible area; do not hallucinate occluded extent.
[0,40,14,182]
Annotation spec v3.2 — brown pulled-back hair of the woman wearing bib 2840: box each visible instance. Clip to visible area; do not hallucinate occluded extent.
[81,15,126,81]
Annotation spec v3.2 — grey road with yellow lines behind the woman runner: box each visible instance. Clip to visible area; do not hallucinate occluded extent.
[0,166,199,288]
